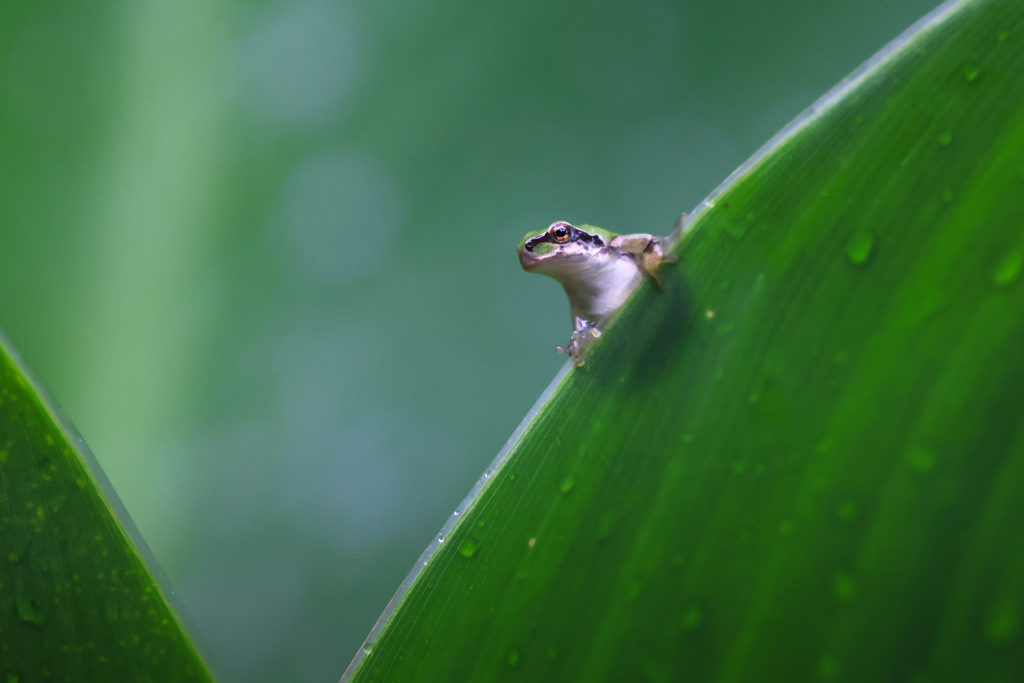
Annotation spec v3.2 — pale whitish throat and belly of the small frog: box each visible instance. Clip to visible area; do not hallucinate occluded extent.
[562,254,643,325]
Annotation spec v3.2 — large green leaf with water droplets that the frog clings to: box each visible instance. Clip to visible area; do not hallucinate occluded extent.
[346,0,1024,683]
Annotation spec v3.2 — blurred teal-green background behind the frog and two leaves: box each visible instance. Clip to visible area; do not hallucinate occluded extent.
[0,0,935,683]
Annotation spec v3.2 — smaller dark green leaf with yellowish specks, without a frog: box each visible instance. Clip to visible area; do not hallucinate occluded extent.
[0,336,213,683]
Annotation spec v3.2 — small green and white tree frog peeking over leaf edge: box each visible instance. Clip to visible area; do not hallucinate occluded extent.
[519,218,686,366]
